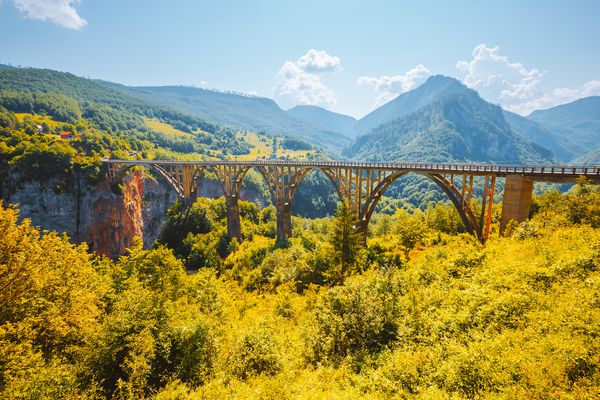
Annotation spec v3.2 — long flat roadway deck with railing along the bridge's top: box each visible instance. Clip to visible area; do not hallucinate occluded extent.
[104,160,600,182]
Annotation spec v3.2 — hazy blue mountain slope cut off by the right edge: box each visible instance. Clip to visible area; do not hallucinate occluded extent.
[528,96,600,154]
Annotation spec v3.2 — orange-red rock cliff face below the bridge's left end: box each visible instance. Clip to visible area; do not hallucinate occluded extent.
[86,171,144,258]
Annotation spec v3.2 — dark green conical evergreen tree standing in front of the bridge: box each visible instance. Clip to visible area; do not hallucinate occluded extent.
[328,201,361,282]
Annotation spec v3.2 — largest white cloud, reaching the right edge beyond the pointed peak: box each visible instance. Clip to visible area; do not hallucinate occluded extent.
[456,43,600,115]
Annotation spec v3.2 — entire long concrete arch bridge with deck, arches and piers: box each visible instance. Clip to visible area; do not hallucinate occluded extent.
[104,160,600,243]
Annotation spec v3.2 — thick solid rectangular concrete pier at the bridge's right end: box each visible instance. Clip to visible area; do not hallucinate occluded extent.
[500,175,533,233]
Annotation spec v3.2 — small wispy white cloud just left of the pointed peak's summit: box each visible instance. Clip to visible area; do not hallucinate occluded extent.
[356,64,431,107]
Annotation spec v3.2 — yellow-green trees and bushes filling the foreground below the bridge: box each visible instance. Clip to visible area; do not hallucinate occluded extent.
[0,185,600,399]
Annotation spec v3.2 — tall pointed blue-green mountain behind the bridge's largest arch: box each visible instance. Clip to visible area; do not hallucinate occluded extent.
[347,83,553,164]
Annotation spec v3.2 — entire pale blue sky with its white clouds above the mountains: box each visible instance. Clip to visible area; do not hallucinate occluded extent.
[0,0,600,117]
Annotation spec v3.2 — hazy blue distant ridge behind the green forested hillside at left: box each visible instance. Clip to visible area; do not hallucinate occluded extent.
[105,82,350,152]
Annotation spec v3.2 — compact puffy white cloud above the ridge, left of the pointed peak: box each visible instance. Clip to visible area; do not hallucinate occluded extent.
[273,49,340,107]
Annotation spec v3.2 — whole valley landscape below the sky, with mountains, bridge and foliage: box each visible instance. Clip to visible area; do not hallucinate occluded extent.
[0,63,600,400]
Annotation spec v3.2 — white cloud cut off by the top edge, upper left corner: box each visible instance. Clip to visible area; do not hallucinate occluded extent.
[13,0,87,29]
